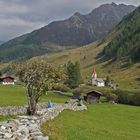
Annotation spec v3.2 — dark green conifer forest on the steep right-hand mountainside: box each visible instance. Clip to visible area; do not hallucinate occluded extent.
[103,6,140,62]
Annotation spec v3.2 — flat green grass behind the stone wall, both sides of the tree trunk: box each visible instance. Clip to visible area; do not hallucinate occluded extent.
[0,85,68,106]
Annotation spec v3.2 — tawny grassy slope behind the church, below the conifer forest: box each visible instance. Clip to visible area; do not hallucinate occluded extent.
[33,42,140,90]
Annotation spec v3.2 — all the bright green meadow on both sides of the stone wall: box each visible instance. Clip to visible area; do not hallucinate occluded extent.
[0,85,140,140]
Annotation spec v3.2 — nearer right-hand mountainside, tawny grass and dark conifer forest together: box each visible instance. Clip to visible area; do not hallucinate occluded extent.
[33,7,140,91]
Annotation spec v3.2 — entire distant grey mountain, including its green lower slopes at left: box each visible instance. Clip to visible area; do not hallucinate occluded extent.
[0,3,135,61]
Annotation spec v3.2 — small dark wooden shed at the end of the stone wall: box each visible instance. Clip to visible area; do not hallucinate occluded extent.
[84,90,103,104]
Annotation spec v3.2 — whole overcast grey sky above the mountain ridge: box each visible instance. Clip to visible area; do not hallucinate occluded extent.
[0,0,140,41]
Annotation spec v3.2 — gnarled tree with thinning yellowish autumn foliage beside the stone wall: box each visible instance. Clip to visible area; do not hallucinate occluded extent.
[13,60,65,115]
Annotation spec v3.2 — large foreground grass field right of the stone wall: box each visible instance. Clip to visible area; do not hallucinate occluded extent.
[42,104,140,140]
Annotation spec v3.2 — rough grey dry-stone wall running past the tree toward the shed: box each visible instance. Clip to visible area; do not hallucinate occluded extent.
[0,102,87,140]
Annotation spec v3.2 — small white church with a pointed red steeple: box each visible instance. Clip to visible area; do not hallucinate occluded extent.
[92,68,105,87]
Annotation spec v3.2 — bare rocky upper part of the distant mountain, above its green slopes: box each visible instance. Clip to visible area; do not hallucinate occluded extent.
[18,3,135,46]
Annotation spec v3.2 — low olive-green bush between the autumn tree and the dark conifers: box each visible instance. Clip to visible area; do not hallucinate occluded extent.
[53,84,71,92]
